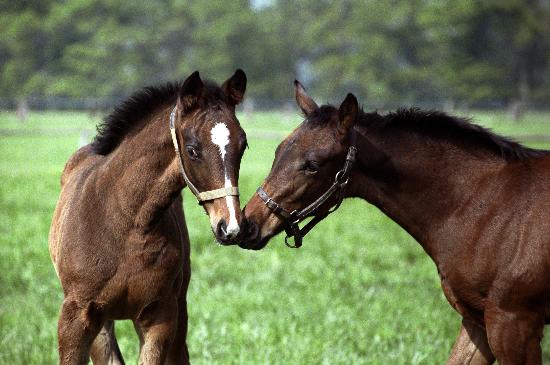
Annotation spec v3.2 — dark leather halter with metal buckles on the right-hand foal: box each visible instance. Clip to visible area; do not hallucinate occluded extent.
[256,132,357,248]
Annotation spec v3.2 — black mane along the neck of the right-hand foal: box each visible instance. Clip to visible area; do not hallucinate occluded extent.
[384,108,550,161]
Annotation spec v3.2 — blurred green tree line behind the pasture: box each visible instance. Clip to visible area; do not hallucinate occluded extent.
[0,0,550,105]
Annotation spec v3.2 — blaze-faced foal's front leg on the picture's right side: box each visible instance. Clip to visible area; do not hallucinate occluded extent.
[134,296,178,365]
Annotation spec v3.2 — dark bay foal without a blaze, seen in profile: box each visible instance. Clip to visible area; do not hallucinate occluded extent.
[244,82,550,365]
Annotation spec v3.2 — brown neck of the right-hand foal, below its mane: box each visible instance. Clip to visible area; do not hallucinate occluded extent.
[350,123,505,262]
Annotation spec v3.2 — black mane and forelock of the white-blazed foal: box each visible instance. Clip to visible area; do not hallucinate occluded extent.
[92,80,228,155]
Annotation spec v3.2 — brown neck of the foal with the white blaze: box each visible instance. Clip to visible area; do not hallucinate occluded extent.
[101,108,185,231]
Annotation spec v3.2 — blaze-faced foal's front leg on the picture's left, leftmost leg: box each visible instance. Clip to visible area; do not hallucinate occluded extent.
[58,298,103,365]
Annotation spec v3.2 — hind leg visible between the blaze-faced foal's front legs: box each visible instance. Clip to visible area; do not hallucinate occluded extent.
[90,321,124,365]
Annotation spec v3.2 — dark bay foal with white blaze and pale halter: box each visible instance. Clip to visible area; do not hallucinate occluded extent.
[49,70,246,364]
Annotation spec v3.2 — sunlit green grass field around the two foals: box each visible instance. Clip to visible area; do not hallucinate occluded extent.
[0,112,550,364]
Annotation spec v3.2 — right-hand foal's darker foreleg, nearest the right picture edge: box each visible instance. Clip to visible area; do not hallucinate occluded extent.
[485,307,544,365]
